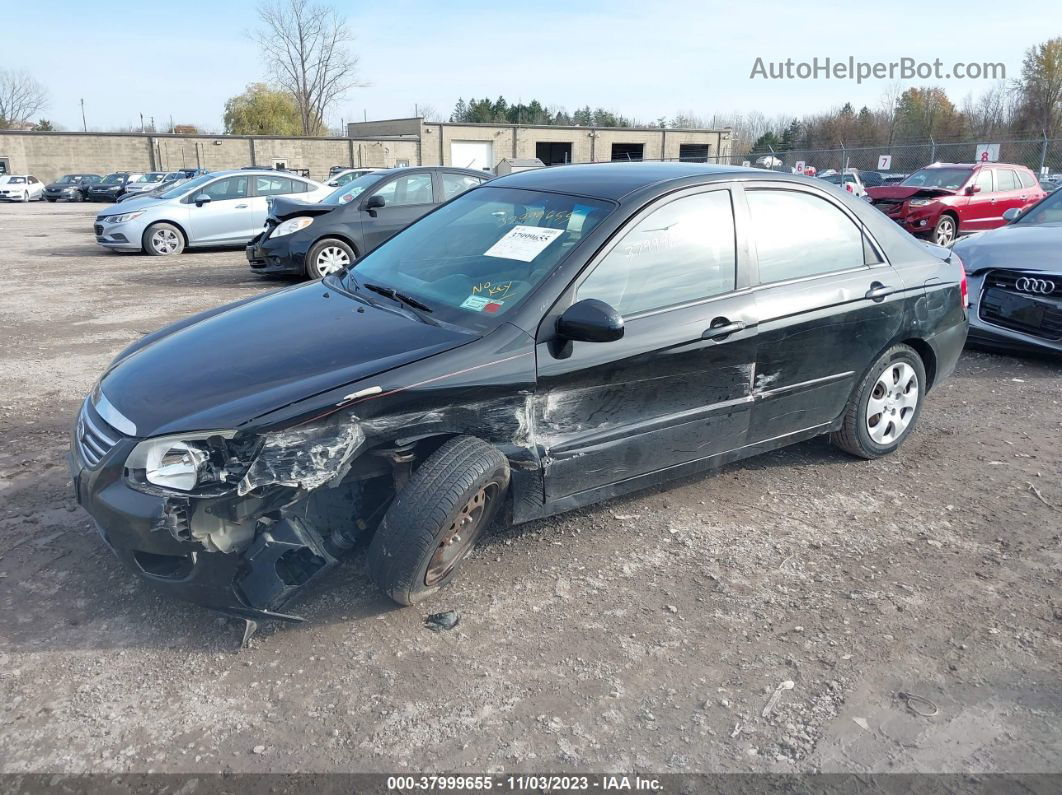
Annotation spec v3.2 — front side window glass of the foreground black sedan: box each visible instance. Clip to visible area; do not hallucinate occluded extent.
[578,190,737,315]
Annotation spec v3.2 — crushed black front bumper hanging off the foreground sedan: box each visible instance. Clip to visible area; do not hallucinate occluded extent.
[69,417,338,621]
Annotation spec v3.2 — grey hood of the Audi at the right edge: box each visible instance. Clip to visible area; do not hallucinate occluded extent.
[954,224,1062,273]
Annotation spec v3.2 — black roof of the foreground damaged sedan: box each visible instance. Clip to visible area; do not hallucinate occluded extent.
[491,162,760,201]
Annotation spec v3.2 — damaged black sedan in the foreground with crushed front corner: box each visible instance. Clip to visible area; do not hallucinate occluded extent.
[71,163,967,619]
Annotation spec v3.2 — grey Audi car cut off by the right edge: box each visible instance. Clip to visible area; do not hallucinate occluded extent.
[953,186,1062,353]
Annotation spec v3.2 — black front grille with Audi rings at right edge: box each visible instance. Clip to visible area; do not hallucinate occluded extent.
[978,271,1062,341]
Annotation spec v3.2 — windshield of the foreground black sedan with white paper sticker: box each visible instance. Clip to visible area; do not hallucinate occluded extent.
[343,188,614,326]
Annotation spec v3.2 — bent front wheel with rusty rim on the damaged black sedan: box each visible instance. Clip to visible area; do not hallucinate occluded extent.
[369,436,509,605]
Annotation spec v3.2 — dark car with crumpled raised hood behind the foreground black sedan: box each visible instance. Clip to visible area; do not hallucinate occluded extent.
[246,167,490,279]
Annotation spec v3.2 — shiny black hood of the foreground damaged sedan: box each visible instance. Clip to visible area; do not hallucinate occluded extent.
[100,282,477,436]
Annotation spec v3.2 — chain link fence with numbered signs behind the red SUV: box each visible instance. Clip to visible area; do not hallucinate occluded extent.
[706,138,1062,176]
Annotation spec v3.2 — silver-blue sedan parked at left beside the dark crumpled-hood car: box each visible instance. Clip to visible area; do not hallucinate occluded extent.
[93,169,332,257]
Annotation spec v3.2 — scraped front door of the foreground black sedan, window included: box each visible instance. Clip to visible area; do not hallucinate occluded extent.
[535,187,757,500]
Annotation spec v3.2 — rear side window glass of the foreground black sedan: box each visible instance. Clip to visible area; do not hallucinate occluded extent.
[746,189,866,283]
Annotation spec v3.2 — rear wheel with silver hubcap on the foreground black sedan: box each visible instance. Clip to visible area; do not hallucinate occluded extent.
[829,345,926,459]
